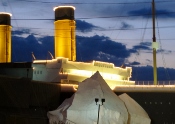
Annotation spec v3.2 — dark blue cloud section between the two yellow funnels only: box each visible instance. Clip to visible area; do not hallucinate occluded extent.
[12,35,54,62]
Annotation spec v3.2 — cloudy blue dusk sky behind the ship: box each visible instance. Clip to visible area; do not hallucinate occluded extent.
[0,0,175,80]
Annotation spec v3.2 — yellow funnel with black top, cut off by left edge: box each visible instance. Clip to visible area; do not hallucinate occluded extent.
[0,12,11,63]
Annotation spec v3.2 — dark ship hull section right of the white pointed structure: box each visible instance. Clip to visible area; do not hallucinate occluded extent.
[116,92,175,124]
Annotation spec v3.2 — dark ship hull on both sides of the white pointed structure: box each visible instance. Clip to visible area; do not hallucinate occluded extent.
[0,76,175,124]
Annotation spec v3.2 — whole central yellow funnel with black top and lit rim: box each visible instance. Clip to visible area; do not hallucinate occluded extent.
[54,6,76,61]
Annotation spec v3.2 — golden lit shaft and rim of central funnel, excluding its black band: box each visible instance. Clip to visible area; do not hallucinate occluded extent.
[54,6,76,61]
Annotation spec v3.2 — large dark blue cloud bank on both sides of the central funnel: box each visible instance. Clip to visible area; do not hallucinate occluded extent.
[12,35,131,66]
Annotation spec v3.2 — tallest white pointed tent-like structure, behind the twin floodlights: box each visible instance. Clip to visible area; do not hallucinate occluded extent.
[48,72,150,124]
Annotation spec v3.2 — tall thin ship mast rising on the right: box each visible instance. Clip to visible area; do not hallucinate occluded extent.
[152,0,157,85]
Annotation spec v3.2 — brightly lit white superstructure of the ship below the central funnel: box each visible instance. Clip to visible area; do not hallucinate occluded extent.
[32,57,135,86]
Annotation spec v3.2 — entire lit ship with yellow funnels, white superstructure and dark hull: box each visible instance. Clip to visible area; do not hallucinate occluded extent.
[0,0,175,124]
